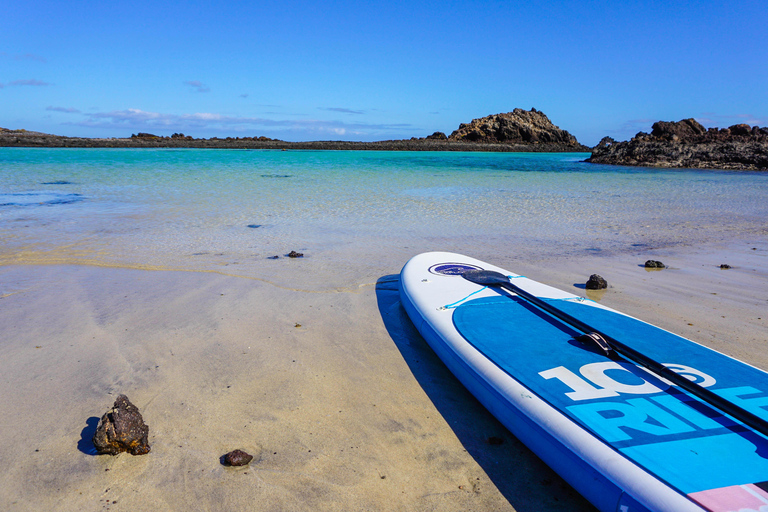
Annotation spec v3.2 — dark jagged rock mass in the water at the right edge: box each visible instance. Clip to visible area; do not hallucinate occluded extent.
[587,119,768,170]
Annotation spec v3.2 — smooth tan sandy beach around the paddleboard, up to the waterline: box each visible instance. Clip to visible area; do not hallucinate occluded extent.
[0,243,768,511]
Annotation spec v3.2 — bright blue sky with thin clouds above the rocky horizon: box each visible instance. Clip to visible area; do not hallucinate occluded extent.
[0,0,768,145]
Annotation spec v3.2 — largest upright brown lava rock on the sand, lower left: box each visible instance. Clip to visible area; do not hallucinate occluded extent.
[93,395,150,455]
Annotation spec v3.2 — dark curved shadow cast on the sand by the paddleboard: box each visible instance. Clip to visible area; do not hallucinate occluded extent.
[376,275,594,512]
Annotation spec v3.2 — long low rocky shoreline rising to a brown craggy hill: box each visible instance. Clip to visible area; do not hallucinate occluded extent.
[0,108,589,152]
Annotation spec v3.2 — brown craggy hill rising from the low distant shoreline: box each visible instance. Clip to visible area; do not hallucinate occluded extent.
[448,108,582,150]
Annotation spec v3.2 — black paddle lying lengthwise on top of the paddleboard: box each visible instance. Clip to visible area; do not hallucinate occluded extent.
[461,270,768,436]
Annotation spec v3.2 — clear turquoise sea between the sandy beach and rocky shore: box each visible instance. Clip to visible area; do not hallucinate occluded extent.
[0,148,768,288]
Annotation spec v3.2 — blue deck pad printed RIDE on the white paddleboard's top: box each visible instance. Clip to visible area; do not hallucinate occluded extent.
[453,295,768,494]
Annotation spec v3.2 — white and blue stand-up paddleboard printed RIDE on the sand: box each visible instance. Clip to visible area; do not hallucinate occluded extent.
[400,252,768,512]
